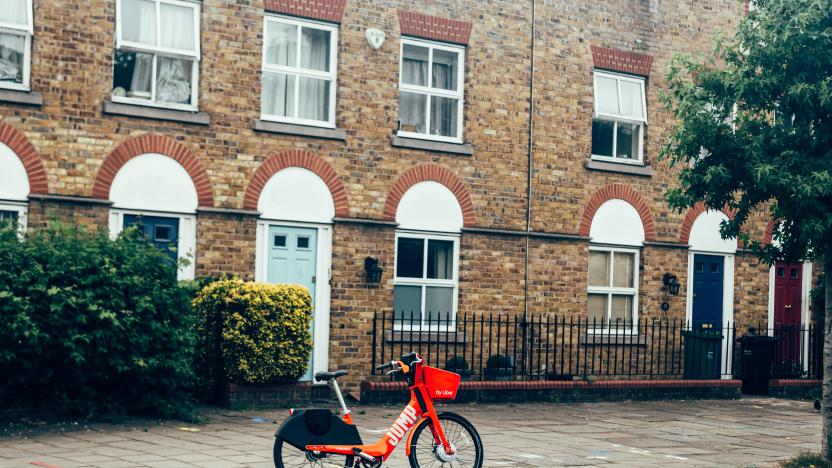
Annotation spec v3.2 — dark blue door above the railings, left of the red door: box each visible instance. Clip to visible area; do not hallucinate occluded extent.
[692,254,725,329]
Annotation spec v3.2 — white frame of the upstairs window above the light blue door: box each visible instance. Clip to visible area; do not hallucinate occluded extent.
[260,15,338,128]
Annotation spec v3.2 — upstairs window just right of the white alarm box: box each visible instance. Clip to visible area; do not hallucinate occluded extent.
[398,39,465,143]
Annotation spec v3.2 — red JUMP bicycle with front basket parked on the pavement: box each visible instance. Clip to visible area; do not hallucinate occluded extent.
[274,353,483,468]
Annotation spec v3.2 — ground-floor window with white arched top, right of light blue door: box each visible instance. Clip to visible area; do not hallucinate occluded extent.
[393,181,463,330]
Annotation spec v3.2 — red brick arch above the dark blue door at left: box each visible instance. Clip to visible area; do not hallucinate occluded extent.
[92,134,214,207]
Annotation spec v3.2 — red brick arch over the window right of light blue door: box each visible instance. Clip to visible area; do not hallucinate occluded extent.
[383,164,477,227]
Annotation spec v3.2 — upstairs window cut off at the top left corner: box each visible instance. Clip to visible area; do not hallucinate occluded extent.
[0,0,33,91]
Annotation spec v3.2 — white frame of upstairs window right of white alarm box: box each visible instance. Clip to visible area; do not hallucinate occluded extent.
[397,37,465,143]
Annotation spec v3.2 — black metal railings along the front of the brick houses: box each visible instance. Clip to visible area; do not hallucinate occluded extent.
[371,312,823,380]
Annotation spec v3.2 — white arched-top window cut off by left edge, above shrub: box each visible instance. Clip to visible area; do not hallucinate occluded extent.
[0,143,29,232]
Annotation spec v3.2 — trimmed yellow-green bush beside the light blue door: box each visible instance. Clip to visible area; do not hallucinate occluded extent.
[193,279,312,383]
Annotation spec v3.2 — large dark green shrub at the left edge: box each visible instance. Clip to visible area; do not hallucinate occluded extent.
[0,224,194,417]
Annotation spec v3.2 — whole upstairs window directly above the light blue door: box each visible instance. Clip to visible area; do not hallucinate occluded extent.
[261,16,338,127]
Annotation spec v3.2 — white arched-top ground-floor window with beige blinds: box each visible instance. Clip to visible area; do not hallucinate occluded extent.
[587,199,644,332]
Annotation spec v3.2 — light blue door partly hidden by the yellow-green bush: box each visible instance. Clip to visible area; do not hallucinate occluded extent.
[267,226,318,380]
